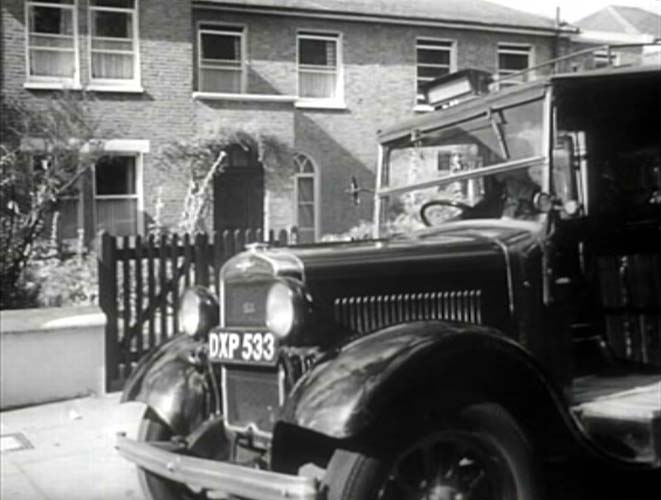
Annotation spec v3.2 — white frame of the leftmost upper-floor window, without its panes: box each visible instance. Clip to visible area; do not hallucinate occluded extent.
[24,0,80,89]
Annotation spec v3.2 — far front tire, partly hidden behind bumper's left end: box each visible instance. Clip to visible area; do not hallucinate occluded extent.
[138,409,206,500]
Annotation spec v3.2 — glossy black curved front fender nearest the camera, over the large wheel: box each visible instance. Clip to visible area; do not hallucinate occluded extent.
[281,322,561,439]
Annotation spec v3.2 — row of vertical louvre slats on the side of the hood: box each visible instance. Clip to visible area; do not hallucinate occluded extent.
[333,290,482,333]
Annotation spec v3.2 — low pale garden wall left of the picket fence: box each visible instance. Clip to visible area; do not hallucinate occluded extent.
[0,306,106,410]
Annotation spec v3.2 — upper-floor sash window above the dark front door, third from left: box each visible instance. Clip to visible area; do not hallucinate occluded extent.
[197,23,246,94]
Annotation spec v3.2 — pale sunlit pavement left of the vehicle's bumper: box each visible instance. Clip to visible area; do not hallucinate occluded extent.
[0,393,144,500]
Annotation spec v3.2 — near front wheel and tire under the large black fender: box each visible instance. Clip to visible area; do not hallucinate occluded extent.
[325,403,541,500]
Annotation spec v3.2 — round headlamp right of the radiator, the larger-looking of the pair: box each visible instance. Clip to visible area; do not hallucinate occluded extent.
[266,281,305,338]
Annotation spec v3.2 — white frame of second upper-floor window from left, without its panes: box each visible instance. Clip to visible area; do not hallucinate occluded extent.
[87,0,142,92]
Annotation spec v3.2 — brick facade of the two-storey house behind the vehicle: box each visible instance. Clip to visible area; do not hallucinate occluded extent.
[2,0,572,241]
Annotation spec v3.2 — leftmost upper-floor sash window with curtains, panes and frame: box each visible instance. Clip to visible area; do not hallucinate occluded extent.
[25,0,78,84]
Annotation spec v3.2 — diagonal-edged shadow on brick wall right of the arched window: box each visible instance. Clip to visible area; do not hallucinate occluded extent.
[295,112,377,236]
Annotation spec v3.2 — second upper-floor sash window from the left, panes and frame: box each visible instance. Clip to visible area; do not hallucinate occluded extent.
[89,0,140,85]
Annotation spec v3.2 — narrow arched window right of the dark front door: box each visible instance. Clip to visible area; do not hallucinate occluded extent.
[294,153,318,243]
